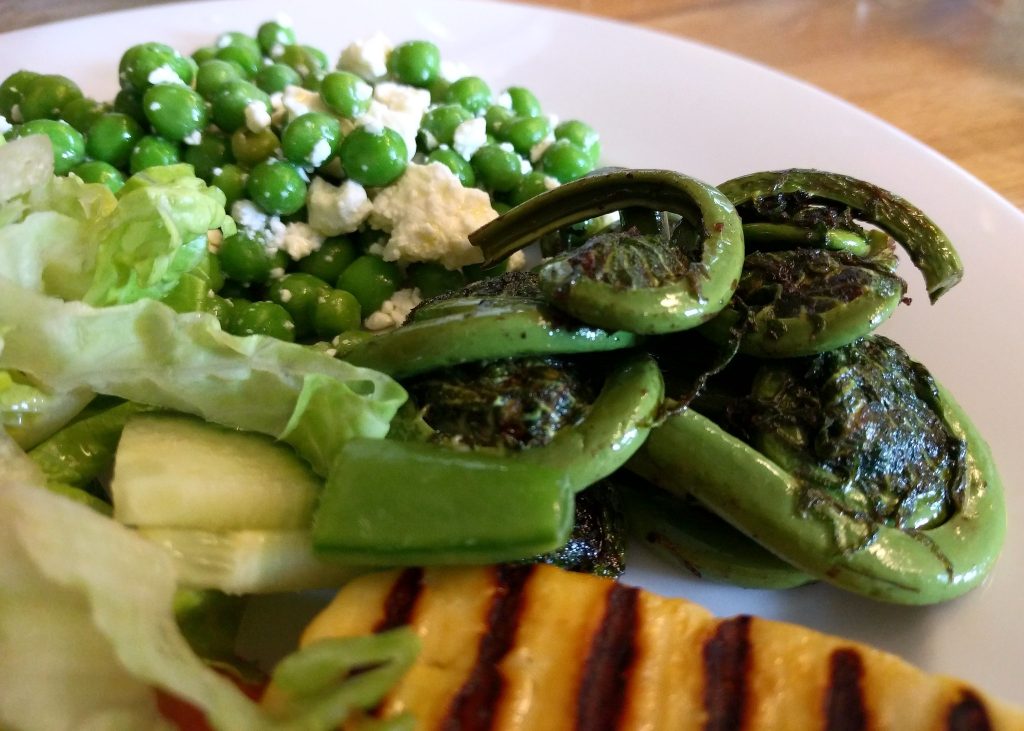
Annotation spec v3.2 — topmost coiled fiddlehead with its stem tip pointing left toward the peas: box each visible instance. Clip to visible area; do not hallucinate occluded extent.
[470,170,743,334]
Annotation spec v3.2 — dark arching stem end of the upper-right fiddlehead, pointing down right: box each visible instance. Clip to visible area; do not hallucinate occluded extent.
[719,169,964,303]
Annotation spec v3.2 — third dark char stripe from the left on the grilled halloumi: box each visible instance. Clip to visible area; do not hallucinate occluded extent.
[575,584,640,731]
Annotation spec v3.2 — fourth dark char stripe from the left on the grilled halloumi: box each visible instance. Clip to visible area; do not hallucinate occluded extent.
[703,614,751,731]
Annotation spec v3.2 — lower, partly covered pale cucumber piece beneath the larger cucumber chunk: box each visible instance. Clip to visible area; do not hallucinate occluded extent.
[139,528,368,594]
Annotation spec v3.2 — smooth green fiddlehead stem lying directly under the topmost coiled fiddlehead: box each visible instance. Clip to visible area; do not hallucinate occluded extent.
[338,302,637,379]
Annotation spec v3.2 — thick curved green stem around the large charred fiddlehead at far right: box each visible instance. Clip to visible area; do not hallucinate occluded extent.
[642,366,1006,604]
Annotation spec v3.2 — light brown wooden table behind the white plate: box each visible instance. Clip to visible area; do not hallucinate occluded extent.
[0,0,1024,209]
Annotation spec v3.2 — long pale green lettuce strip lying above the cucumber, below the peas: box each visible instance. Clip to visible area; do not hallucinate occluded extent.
[0,277,406,474]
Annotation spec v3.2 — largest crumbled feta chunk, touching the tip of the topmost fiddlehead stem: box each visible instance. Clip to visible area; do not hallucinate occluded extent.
[370,163,498,269]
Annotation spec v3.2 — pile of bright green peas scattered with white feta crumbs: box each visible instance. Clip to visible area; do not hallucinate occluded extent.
[0,20,600,343]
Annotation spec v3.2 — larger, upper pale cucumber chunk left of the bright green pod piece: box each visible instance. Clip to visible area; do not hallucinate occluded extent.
[111,414,322,530]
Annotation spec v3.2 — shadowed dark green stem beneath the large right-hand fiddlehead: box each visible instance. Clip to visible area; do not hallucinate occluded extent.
[621,473,814,590]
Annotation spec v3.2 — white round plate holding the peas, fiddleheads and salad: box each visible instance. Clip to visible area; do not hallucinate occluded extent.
[0,0,1024,704]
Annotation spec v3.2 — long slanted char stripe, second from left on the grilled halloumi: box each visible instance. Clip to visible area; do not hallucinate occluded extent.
[439,565,535,731]
